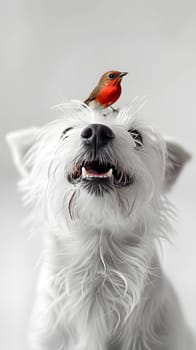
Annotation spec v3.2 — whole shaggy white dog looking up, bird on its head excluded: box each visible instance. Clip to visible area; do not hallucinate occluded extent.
[5,102,196,350]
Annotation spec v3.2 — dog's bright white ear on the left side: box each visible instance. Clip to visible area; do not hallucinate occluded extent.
[6,128,39,176]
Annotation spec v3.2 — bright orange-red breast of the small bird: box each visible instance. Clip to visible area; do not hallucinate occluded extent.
[95,84,121,107]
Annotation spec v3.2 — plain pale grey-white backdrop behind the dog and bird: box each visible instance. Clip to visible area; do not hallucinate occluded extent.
[0,0,196,350]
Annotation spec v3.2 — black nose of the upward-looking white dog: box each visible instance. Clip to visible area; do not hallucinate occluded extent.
[81,124,115,148]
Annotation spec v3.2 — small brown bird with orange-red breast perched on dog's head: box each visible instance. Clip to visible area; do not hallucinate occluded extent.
[84,70,128,109]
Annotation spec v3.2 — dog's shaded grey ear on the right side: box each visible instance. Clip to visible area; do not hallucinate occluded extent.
[165,139,191,191]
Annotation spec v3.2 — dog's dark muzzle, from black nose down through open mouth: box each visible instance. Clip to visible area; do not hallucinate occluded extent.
[68,124,134,195]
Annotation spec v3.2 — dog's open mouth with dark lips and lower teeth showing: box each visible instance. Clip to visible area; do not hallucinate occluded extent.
[68,161,134,188]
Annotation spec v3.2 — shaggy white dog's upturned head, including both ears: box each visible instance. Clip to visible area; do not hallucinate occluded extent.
[7,103,190,232]
